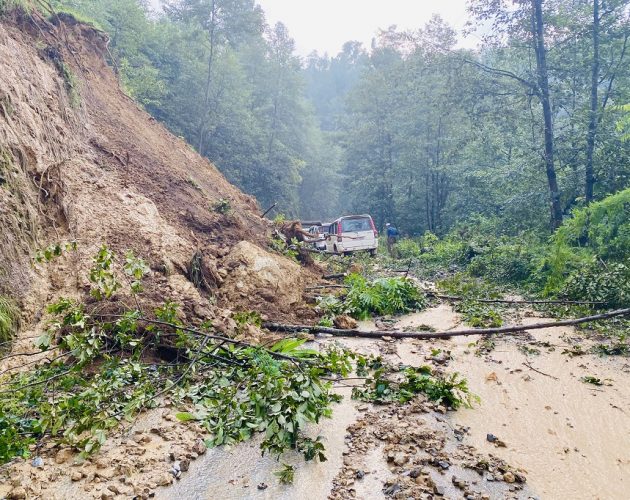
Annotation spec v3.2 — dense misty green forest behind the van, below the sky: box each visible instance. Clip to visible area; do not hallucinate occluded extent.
[47,0,630,237]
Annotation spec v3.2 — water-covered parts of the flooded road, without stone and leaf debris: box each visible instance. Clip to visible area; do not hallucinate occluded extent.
[158,305,630,499]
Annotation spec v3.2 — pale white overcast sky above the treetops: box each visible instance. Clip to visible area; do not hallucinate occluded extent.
[257,0,478,56]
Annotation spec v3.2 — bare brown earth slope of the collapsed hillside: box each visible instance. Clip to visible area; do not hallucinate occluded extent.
[0,11,312,344]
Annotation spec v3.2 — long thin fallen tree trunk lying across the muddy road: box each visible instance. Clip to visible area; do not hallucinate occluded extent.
[263,308,630,339]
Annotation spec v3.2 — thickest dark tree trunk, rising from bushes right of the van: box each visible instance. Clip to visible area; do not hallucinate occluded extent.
[532,0,562,229]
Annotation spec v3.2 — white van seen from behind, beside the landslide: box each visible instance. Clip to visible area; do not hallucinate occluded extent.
[326,215,378,256]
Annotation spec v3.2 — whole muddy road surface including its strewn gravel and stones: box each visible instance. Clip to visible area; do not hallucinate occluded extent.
[158,305,630,499]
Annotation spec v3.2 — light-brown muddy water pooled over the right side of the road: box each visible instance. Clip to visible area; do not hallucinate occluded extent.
[398,306,630,499]
